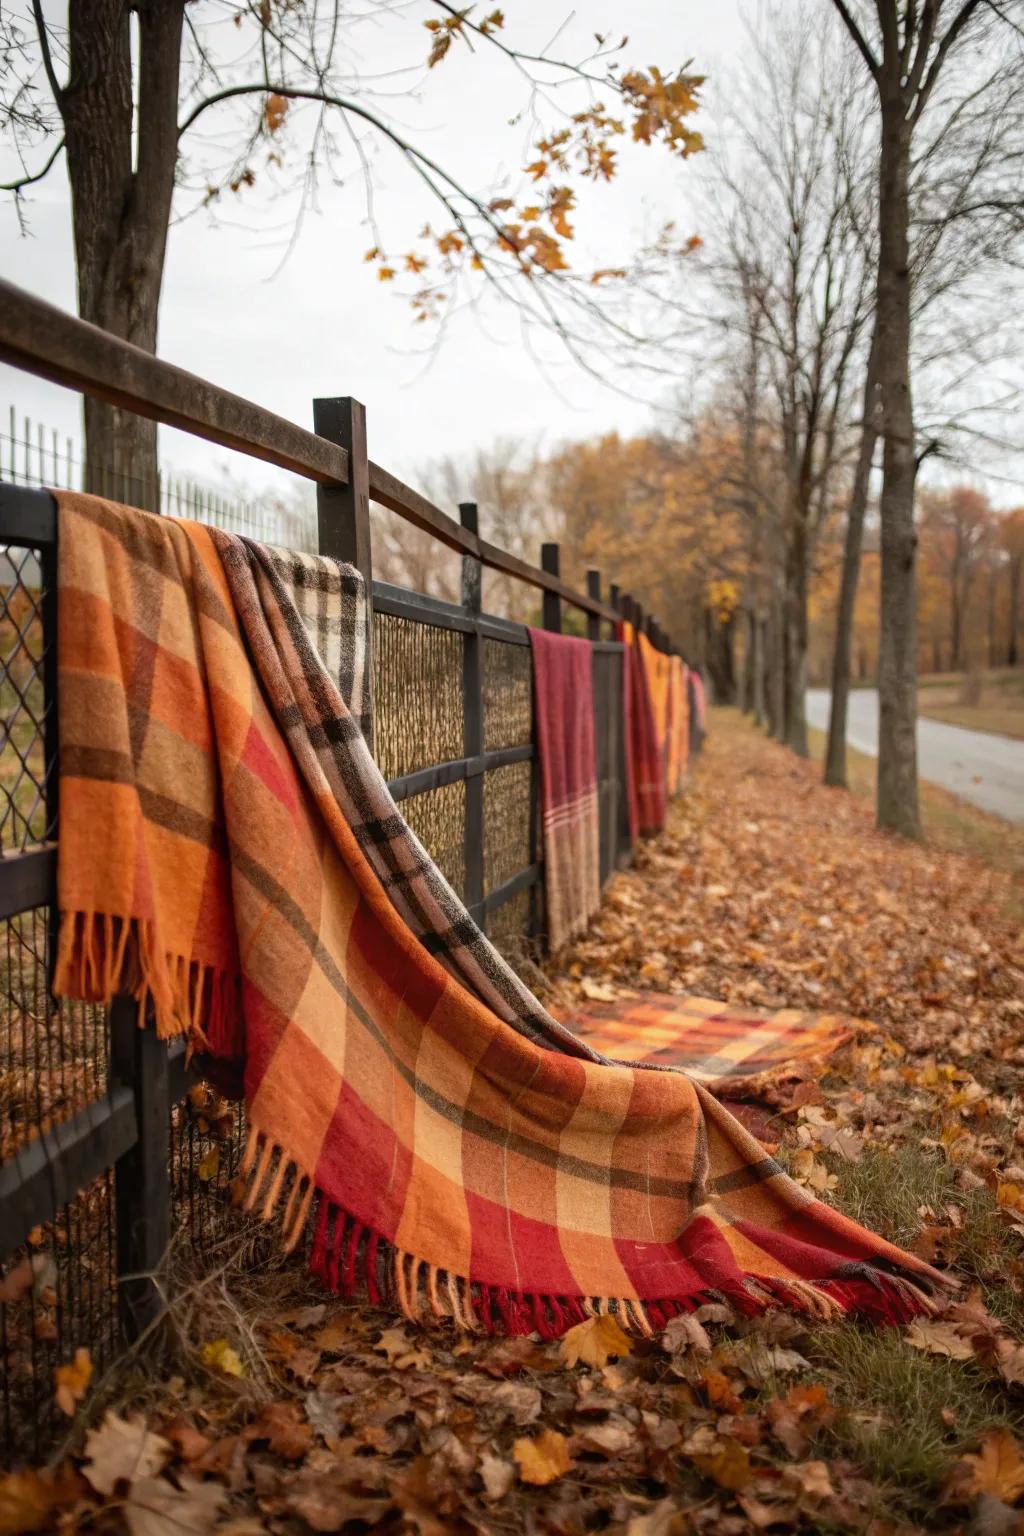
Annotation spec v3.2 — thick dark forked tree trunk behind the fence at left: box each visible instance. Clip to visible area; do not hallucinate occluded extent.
[58,0,184,511]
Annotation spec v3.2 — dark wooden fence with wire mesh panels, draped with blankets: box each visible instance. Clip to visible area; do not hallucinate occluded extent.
[0,283,684,1459]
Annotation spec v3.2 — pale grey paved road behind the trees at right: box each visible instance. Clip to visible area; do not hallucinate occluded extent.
[808,688,1024,822]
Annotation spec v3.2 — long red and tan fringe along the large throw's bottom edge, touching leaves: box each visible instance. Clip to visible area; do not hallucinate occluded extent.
[241,1127,938,1339]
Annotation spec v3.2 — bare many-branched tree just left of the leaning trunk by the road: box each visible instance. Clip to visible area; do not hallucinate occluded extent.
[687,6,870,756]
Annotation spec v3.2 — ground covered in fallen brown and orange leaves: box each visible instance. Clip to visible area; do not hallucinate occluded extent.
[0,720,1024,1536]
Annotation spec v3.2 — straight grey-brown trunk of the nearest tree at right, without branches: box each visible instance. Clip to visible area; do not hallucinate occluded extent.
[877,92,921,839]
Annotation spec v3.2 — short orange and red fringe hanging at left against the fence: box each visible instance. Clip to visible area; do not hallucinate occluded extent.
[54,912,246,1058]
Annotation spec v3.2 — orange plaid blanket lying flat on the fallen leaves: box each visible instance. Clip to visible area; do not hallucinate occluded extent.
[565,992,854,1097]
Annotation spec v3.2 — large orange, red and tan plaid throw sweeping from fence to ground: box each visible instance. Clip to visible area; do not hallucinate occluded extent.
[55,498,941,1335]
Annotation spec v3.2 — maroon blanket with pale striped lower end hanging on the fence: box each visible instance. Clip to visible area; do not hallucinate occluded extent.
[530,630,600,951]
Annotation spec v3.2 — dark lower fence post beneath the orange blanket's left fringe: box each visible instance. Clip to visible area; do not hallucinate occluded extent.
[107,997,170,1339]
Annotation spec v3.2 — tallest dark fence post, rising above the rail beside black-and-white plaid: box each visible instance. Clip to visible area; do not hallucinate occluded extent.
[313,395,373,751]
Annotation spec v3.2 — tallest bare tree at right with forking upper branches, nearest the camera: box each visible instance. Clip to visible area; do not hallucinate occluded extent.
[832,0,1024,837]
